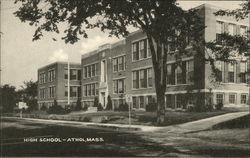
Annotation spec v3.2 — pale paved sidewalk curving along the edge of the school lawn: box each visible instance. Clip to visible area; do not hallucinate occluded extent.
[2,112,249,133]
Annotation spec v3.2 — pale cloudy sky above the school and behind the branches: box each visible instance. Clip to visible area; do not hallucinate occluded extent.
[0,0,246,89]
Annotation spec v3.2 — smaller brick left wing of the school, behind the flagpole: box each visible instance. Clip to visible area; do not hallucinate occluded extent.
[38,62,82,109]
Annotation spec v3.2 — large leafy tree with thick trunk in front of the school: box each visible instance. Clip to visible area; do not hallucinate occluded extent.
[14,0,204,125]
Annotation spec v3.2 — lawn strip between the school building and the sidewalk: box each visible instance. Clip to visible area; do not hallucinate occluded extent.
[3,108,246,126]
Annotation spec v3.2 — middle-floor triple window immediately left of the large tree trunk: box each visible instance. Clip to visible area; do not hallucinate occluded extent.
[132,68,153,89]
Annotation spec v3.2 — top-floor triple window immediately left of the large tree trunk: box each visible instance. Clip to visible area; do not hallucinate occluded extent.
[132,39,151,61]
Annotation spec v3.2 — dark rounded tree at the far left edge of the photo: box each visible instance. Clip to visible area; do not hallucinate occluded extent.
[0,84,17,112]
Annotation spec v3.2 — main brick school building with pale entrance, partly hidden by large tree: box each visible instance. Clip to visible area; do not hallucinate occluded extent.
[81,4,249,109]
